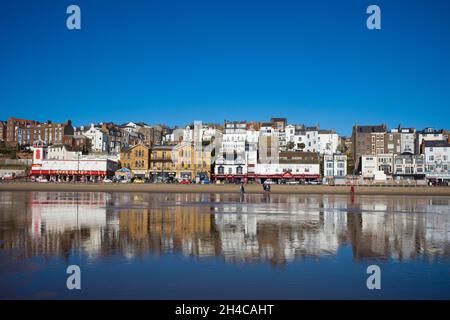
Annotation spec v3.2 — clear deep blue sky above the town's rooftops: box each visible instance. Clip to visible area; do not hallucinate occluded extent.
[0,0,450,134]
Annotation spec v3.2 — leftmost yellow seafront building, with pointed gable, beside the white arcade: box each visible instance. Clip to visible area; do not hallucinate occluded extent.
[120,144,151,178]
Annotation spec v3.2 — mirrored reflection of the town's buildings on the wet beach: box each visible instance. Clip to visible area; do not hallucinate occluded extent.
[0,192,450,265]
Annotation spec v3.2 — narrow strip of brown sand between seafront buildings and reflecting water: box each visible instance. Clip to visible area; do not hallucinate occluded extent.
[0,182,450,196]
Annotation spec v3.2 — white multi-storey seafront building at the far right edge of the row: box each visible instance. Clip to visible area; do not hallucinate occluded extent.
[423,140,450,181]
